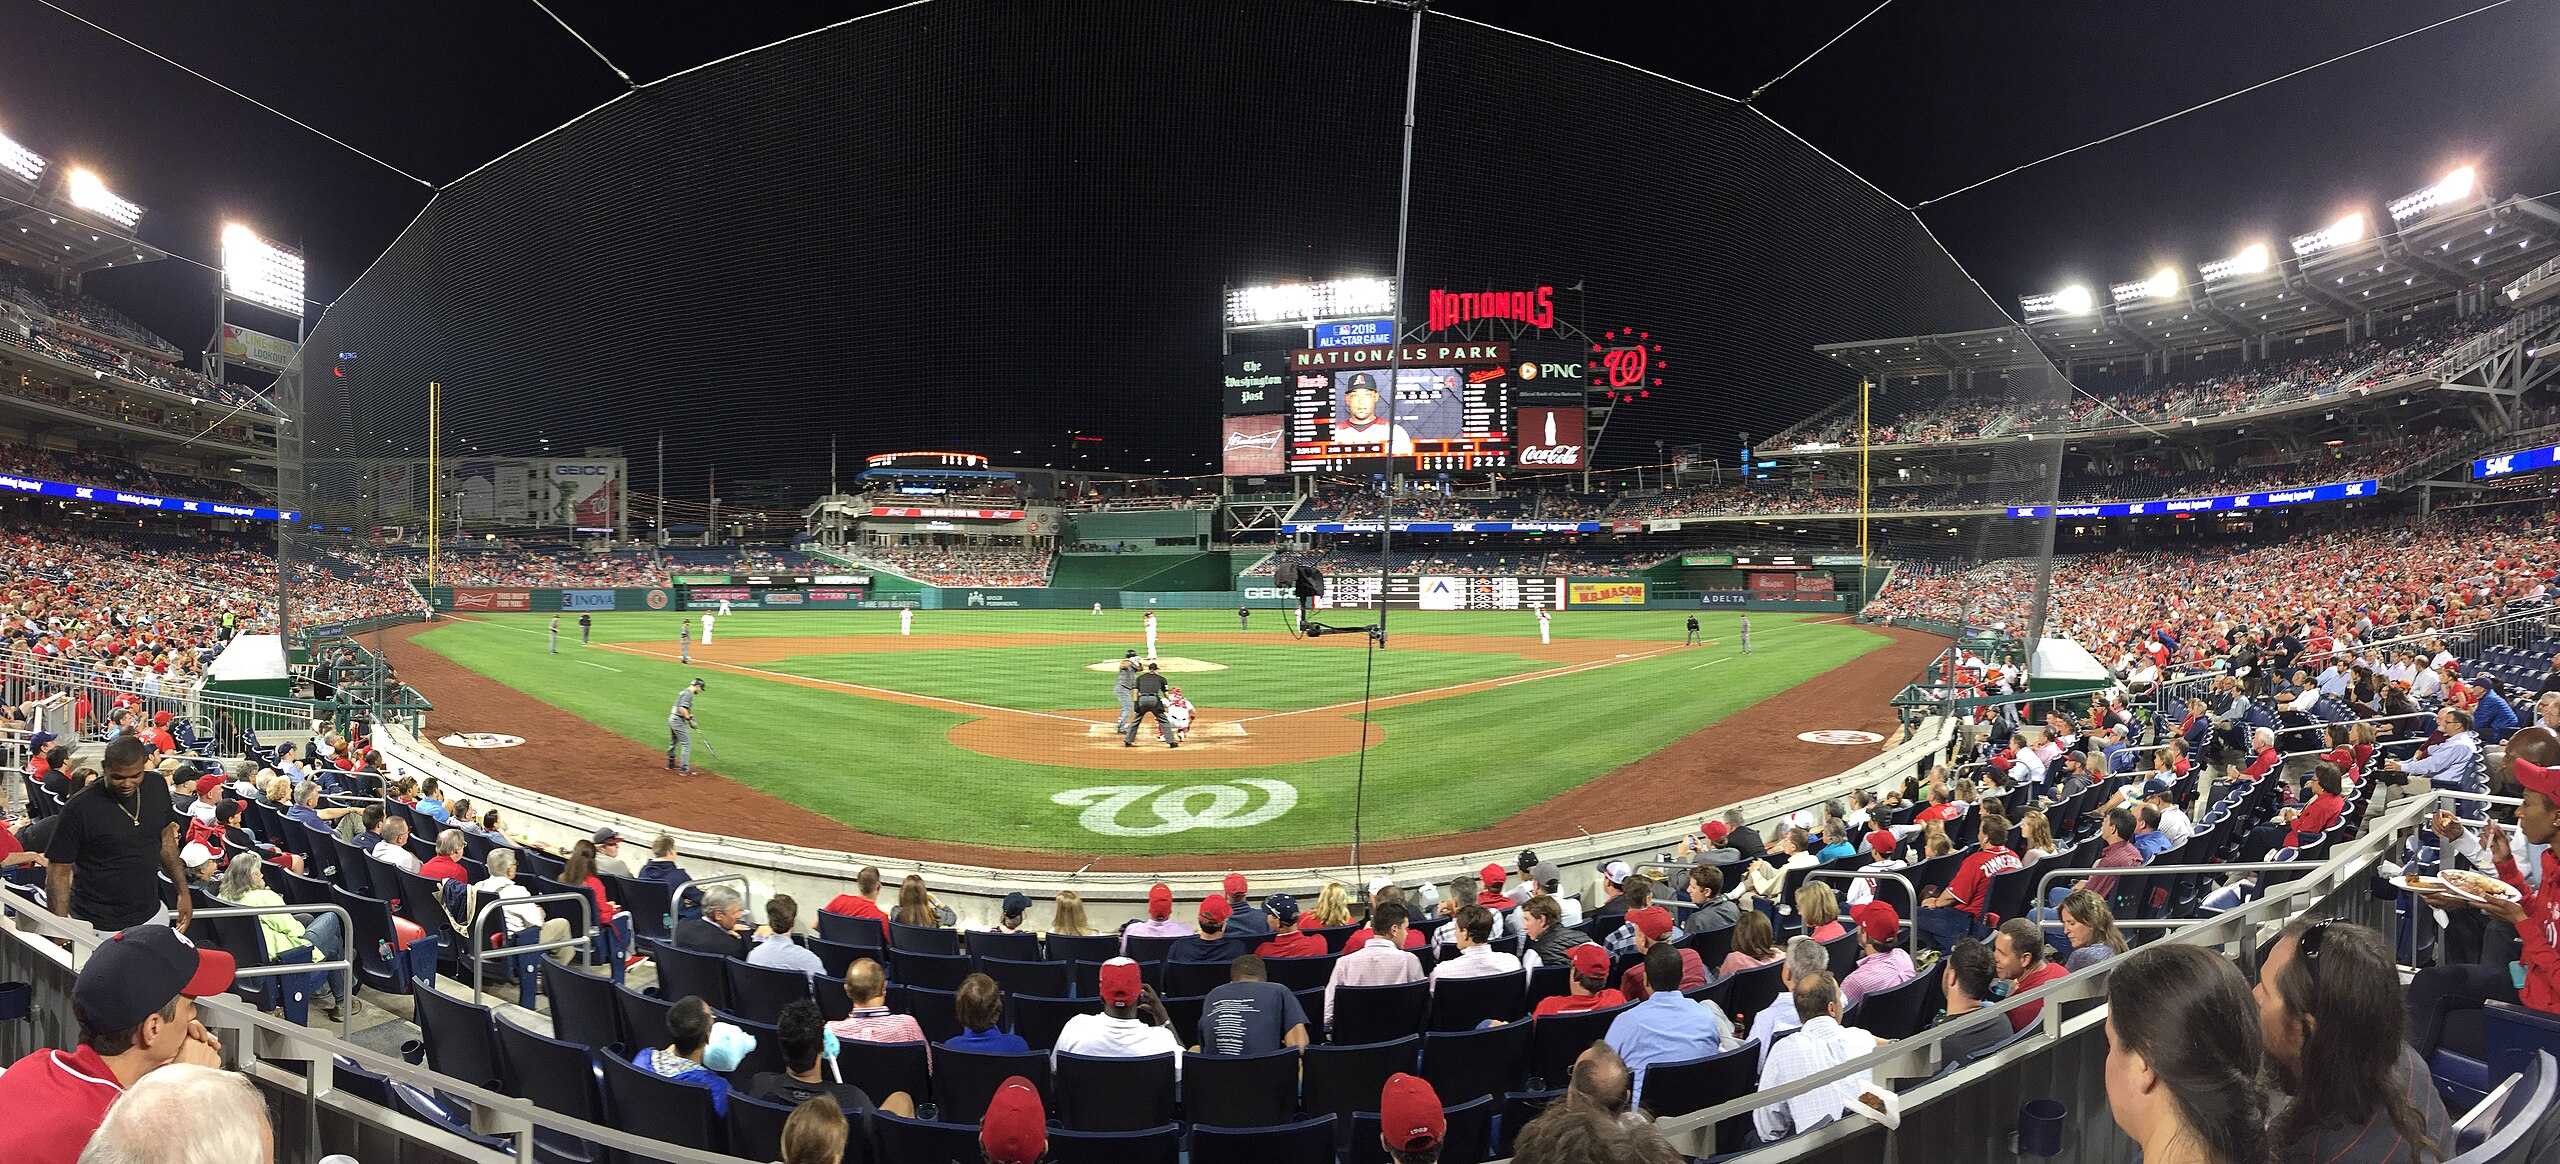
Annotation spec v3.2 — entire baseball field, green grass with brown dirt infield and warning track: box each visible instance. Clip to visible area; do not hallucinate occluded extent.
[394,609,1933,860]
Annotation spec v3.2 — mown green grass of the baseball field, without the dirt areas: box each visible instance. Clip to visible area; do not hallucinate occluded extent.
[417,611,1887,854]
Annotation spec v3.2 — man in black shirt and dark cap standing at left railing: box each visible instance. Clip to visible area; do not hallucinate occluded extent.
[44,734,195,934]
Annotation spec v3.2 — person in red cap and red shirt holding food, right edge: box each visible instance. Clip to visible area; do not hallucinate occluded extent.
[2409,760,2560,1057]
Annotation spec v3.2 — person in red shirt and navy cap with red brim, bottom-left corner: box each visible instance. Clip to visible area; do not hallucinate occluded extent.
[0,926,233,1164]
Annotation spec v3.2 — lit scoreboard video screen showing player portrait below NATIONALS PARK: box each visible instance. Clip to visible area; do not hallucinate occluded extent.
[1288,368,1510,473]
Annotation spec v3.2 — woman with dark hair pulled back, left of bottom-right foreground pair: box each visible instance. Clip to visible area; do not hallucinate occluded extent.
[2107,944,2268,1164]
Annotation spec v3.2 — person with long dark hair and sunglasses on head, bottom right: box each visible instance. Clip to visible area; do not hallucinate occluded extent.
[2258,918,2452,1164]
